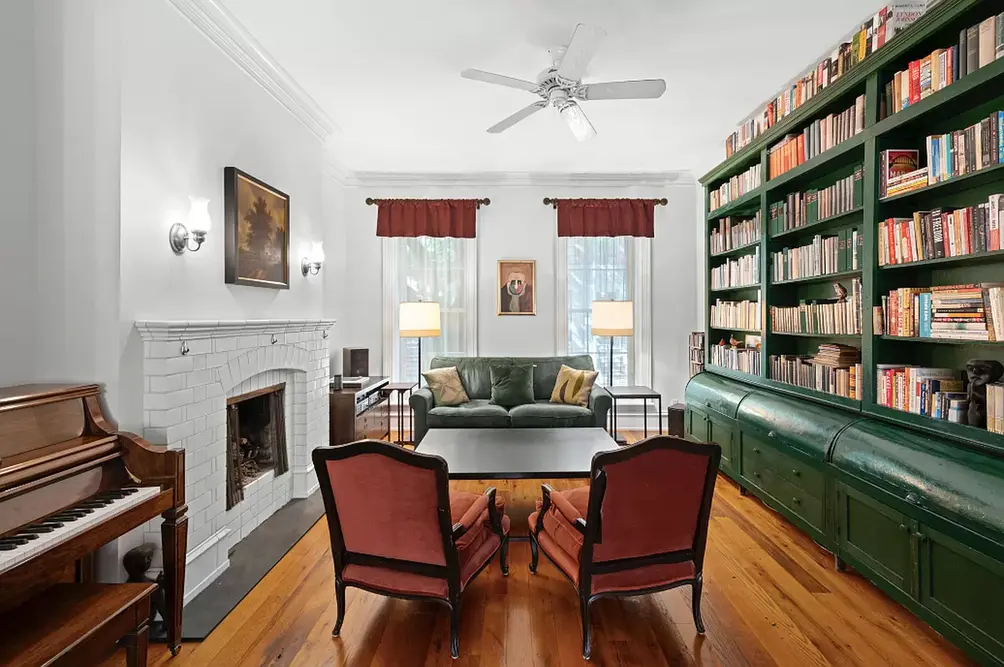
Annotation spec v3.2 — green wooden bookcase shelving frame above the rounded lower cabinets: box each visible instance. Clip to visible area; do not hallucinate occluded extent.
[702,0,1004,453]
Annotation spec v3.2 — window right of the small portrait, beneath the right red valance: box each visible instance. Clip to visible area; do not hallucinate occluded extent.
[564,236,636,386]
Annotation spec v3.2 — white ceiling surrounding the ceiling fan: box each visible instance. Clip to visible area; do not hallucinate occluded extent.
[222,0,880,174]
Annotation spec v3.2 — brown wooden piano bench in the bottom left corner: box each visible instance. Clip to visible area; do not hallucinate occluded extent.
[0,584,157,667]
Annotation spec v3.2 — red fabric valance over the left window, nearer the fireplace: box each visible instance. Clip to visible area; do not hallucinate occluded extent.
[377,199,478,238]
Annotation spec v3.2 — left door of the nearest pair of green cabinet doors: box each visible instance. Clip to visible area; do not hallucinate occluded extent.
[836,484,918,598]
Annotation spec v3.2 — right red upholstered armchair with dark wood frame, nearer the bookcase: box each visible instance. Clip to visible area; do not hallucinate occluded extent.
[529,436,722,660]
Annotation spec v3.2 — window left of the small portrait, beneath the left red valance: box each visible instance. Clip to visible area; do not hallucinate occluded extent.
[384,236,477,381]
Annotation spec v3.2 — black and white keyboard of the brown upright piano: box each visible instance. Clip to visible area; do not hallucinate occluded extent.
[0,486,161,574]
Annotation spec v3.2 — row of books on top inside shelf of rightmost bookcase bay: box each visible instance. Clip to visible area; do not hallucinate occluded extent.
[880,12,1004,119]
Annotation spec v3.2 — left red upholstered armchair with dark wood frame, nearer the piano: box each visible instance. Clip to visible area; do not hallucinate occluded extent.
[313,440,509,658]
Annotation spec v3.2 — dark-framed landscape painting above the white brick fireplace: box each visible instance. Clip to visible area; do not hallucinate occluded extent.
[223,167,289,289]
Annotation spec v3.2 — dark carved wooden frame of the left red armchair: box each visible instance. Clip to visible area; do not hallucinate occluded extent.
[312,440,509,658]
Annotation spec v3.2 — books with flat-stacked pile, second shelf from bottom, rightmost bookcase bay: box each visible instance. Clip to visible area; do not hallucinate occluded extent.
[881,282,1004,342]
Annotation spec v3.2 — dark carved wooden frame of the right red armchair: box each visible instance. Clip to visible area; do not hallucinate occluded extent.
[530,435,722,660]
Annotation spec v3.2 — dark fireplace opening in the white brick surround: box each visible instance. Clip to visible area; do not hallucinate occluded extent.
[227,383,289,509]
